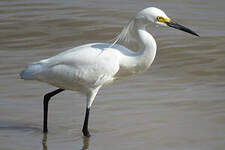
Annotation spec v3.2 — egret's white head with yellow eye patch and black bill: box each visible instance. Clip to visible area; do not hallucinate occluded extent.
[135,7,199,36]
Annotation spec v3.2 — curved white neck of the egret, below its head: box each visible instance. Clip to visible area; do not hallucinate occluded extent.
[117,19,157,75]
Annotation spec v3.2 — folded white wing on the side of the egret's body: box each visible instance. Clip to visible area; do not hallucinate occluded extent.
[37,42,119,88]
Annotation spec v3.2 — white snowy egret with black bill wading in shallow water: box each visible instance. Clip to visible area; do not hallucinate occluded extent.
[20,7,198,137]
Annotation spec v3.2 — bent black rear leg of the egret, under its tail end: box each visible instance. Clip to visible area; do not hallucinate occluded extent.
[43,89,64,133]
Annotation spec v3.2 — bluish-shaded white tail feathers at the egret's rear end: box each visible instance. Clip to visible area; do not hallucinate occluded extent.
[20,63,44,80]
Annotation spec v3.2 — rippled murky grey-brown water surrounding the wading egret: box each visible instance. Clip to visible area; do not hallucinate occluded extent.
[0,0,225,150]
